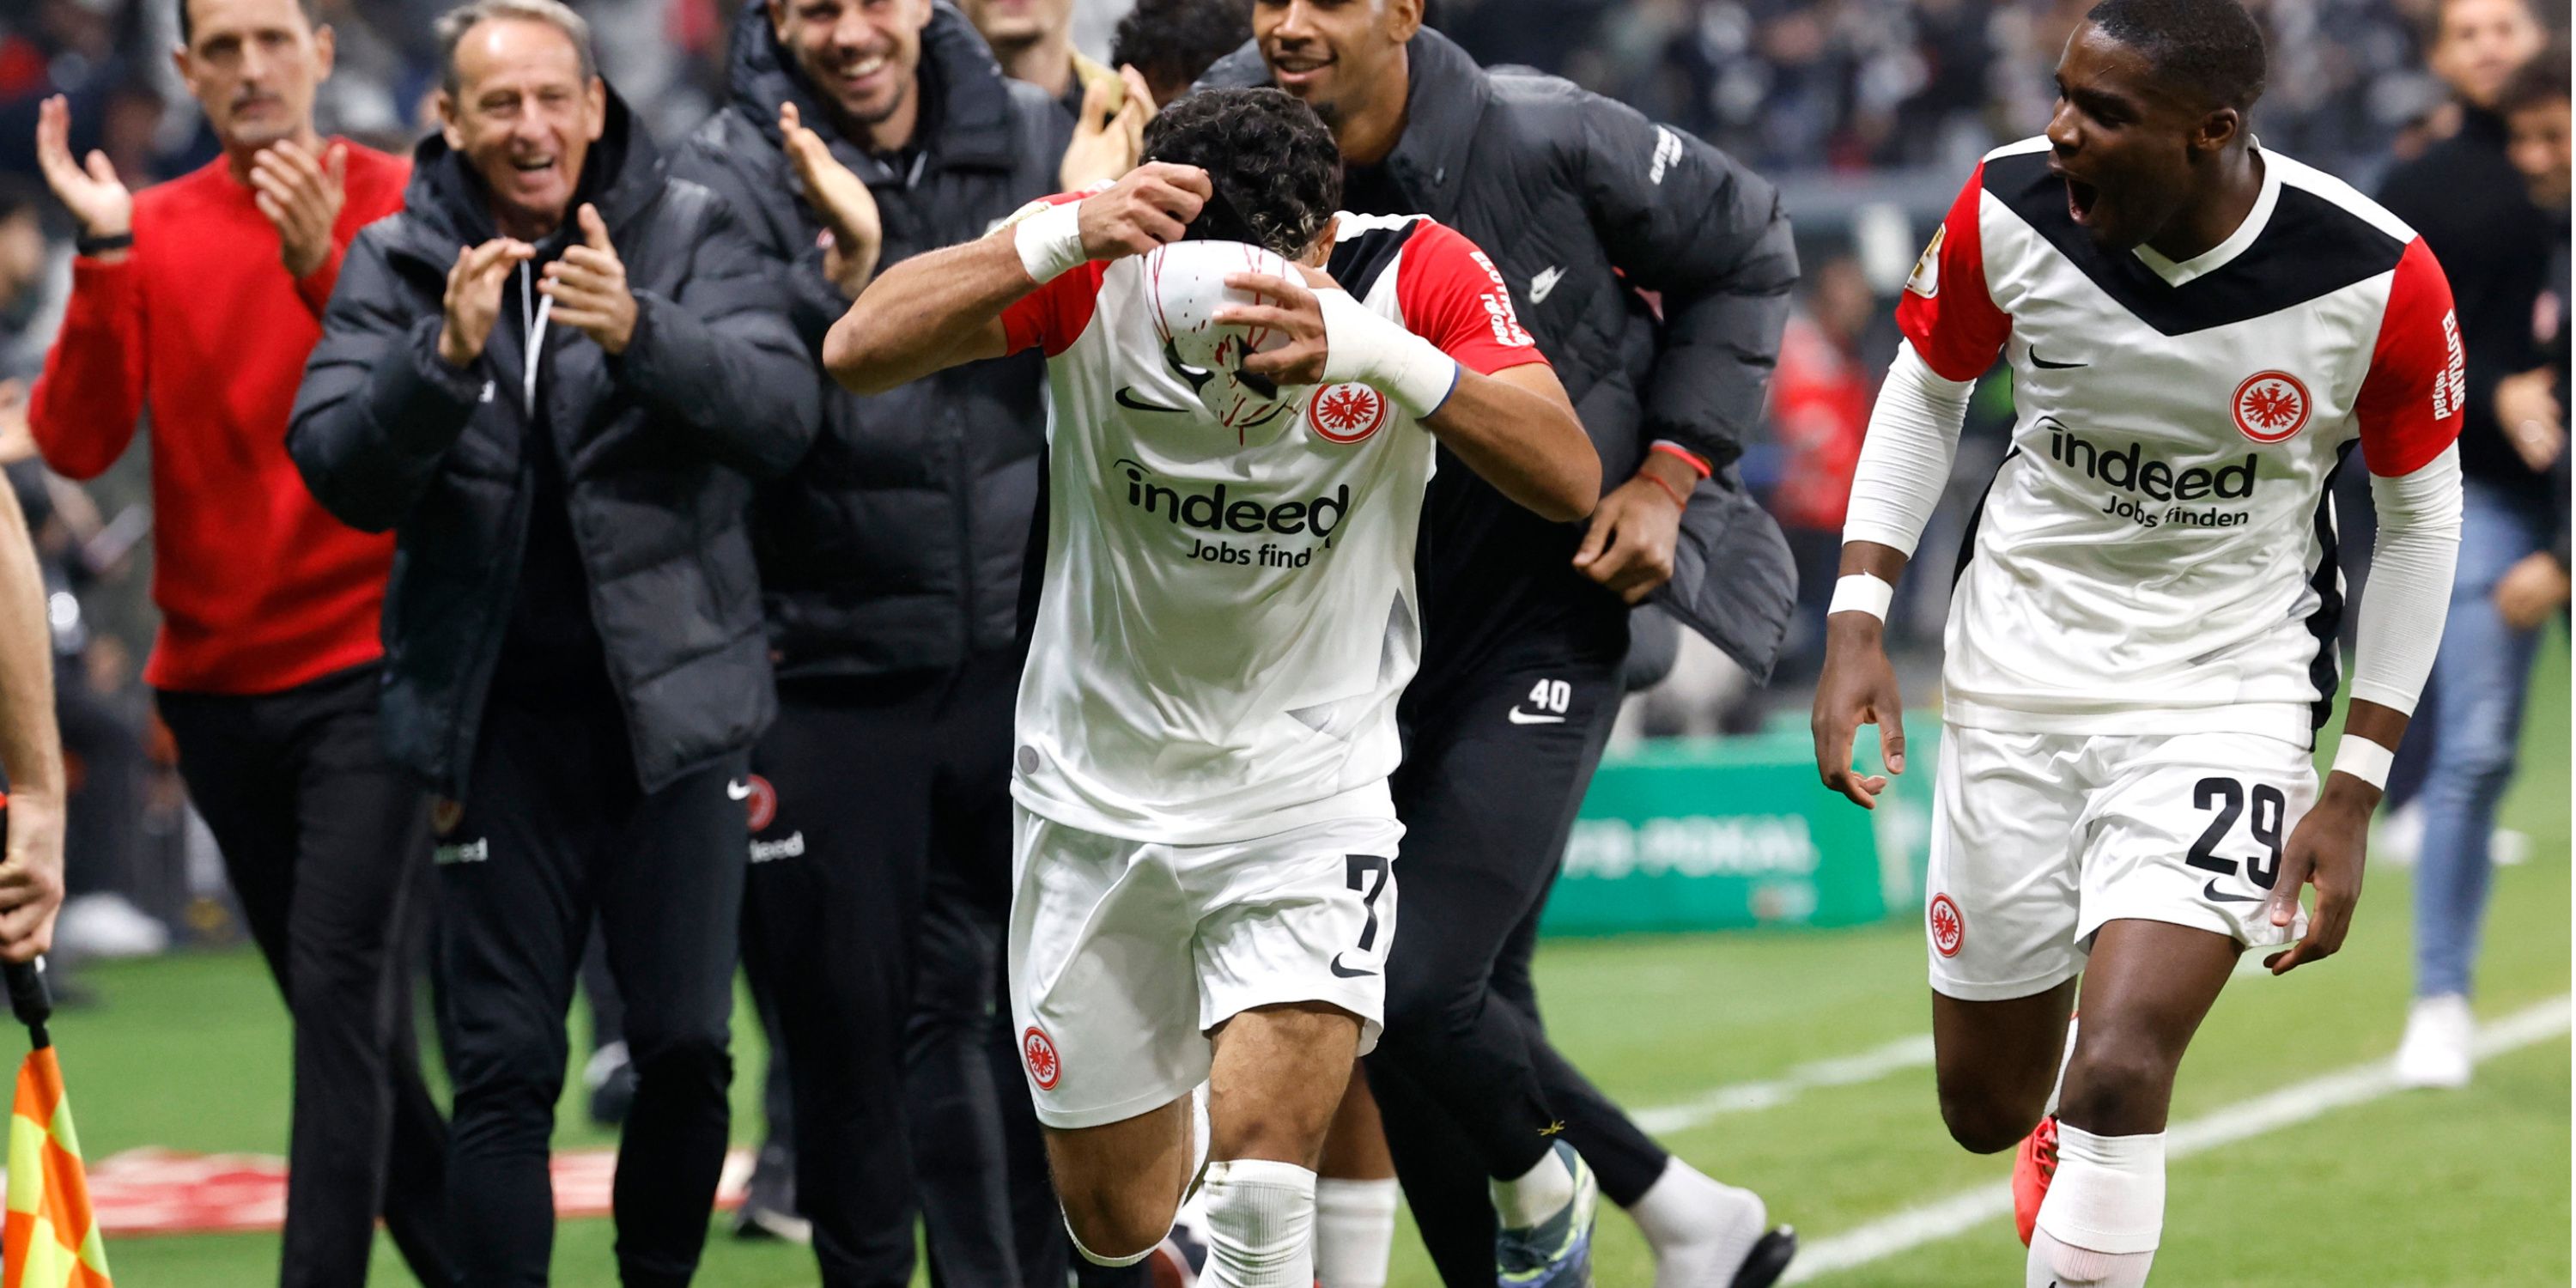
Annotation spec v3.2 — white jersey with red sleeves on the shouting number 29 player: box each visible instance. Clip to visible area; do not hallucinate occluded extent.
[1896,139,2465,742]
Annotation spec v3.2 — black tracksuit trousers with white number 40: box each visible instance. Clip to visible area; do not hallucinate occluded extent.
[1365,649,1669,1288]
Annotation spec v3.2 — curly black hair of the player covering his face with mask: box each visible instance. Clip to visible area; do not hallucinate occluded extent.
[1144,88,1342,260]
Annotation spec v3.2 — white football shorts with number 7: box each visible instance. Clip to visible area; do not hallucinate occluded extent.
[1010,804,1404,1128]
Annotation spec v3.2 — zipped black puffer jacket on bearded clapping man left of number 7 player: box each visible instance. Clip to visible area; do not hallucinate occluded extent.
[672,0,1072,680]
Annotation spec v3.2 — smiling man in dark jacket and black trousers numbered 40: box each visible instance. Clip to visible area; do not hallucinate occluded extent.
[1200,0,1798,1288]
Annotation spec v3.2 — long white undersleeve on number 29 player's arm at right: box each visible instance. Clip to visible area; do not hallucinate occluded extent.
[2352,443,2460,716]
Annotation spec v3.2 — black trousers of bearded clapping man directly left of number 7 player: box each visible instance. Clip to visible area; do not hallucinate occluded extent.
[742,654,1064,1288]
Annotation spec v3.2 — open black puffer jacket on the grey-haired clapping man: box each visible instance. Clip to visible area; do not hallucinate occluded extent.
[286,95,819,796]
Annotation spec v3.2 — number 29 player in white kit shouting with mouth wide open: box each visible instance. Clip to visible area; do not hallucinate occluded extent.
[1816,0,2465,1288]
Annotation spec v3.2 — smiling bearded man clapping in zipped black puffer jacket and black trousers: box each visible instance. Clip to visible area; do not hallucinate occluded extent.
[675,0,1072,1288]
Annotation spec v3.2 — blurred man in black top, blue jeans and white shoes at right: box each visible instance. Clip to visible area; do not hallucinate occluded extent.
[2380,0,2566,1087]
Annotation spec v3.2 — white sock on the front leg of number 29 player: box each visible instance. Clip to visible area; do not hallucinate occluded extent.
[2027,1121,2164,1288]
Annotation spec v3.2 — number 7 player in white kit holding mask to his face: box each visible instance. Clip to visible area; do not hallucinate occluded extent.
[824,90,1600,1288]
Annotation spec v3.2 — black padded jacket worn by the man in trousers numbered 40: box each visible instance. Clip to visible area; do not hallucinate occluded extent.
[1200,28,1798,685]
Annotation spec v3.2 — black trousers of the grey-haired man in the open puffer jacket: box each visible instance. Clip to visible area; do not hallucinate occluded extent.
[435,698,750,1288]
